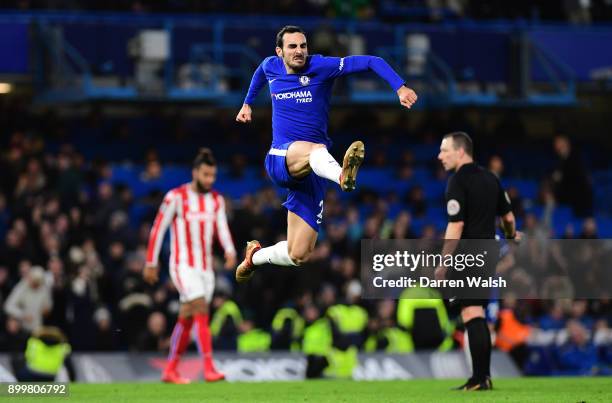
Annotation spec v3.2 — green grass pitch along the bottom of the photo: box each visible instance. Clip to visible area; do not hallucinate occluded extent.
[17,377,612,403]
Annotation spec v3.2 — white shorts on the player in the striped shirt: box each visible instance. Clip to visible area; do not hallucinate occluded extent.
[170,265,215,303]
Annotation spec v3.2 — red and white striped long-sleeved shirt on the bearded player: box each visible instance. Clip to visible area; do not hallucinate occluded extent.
[147,183,236,270]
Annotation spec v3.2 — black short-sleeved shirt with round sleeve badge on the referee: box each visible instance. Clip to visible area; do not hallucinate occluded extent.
[446,163,512,239]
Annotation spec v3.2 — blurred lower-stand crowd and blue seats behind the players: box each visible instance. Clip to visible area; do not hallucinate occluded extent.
[0,99,612,374]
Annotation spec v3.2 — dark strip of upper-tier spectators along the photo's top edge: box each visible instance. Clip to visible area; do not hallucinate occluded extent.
[1,0,612,24]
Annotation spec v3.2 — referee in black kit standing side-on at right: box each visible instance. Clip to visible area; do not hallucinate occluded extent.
[435,132,520,391]
